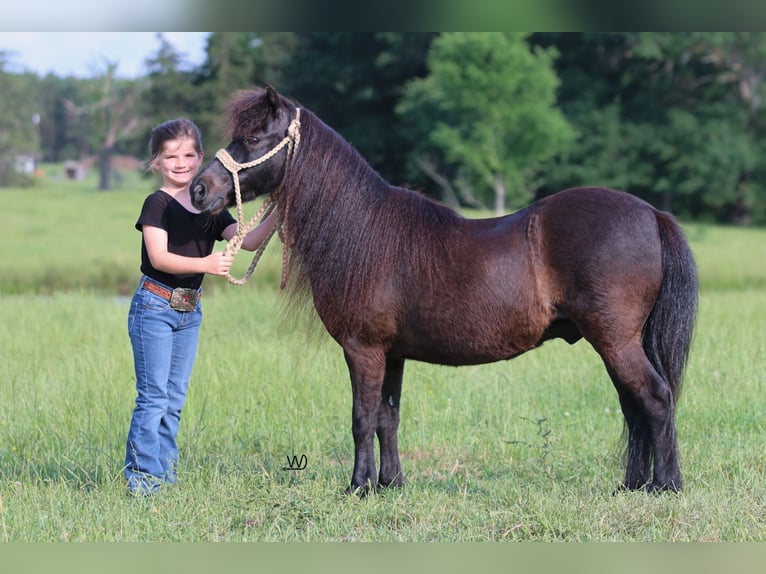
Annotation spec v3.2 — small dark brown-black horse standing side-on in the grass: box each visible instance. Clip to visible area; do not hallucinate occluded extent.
[191,87,698,491]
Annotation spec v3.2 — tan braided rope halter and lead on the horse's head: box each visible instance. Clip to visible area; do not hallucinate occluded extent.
[215,108,301,288]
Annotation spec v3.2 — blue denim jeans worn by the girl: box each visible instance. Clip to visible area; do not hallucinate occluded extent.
[125,277,202,493]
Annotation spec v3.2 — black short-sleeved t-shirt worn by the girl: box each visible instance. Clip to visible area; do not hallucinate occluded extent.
[136,190,236,289]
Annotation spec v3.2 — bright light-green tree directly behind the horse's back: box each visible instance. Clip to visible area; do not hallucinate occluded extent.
[400,32,574,213]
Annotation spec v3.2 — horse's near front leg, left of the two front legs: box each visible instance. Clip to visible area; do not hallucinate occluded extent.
[343,345,386,494]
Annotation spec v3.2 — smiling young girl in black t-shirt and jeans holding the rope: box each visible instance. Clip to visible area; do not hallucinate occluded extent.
[125,118,275,494]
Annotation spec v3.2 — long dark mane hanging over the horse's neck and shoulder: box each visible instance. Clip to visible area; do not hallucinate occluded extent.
[280,109,463,333]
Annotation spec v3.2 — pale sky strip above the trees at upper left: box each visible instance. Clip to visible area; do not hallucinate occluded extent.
[0,32,209,78]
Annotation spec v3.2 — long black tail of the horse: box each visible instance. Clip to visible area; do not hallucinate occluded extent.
[643,212,698,402]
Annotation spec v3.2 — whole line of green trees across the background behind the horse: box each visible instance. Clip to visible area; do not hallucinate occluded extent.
[0,32,766,225]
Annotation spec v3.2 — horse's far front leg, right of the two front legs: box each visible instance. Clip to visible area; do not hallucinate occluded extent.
[377,359,404,486]
